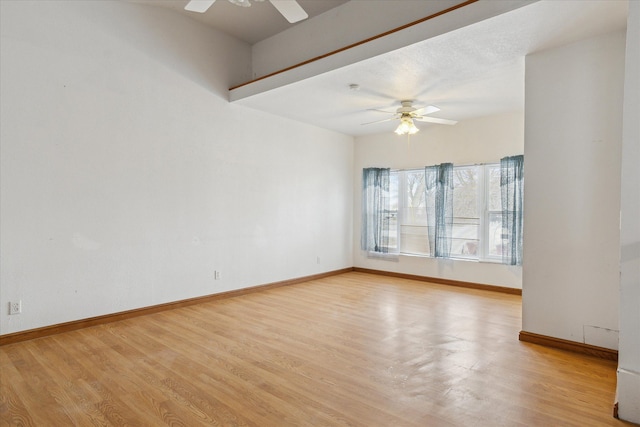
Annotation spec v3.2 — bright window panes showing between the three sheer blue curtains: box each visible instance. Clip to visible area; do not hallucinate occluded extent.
[370,163,504,261]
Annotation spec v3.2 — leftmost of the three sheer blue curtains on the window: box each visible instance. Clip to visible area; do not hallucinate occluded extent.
[360,168,391,253]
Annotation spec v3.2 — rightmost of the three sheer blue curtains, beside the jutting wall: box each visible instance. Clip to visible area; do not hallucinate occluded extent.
[500,155,524,265]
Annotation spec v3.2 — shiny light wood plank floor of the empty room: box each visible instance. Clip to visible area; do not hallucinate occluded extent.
[0,272,627,427]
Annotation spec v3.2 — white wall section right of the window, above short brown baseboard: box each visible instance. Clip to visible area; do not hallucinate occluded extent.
[522,33,625,349]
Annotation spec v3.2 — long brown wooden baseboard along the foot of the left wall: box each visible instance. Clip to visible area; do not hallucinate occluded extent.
[0,267,353,346]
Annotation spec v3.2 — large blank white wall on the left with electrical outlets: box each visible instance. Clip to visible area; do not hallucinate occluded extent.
[0,1,353,334]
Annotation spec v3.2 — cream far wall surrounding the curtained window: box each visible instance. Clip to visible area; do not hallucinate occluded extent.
[353,112,527,288]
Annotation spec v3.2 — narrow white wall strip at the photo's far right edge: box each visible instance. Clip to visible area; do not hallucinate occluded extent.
[617,2,640,424]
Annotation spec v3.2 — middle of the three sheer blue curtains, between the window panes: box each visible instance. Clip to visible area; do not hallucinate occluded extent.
[424,163,453,258]
